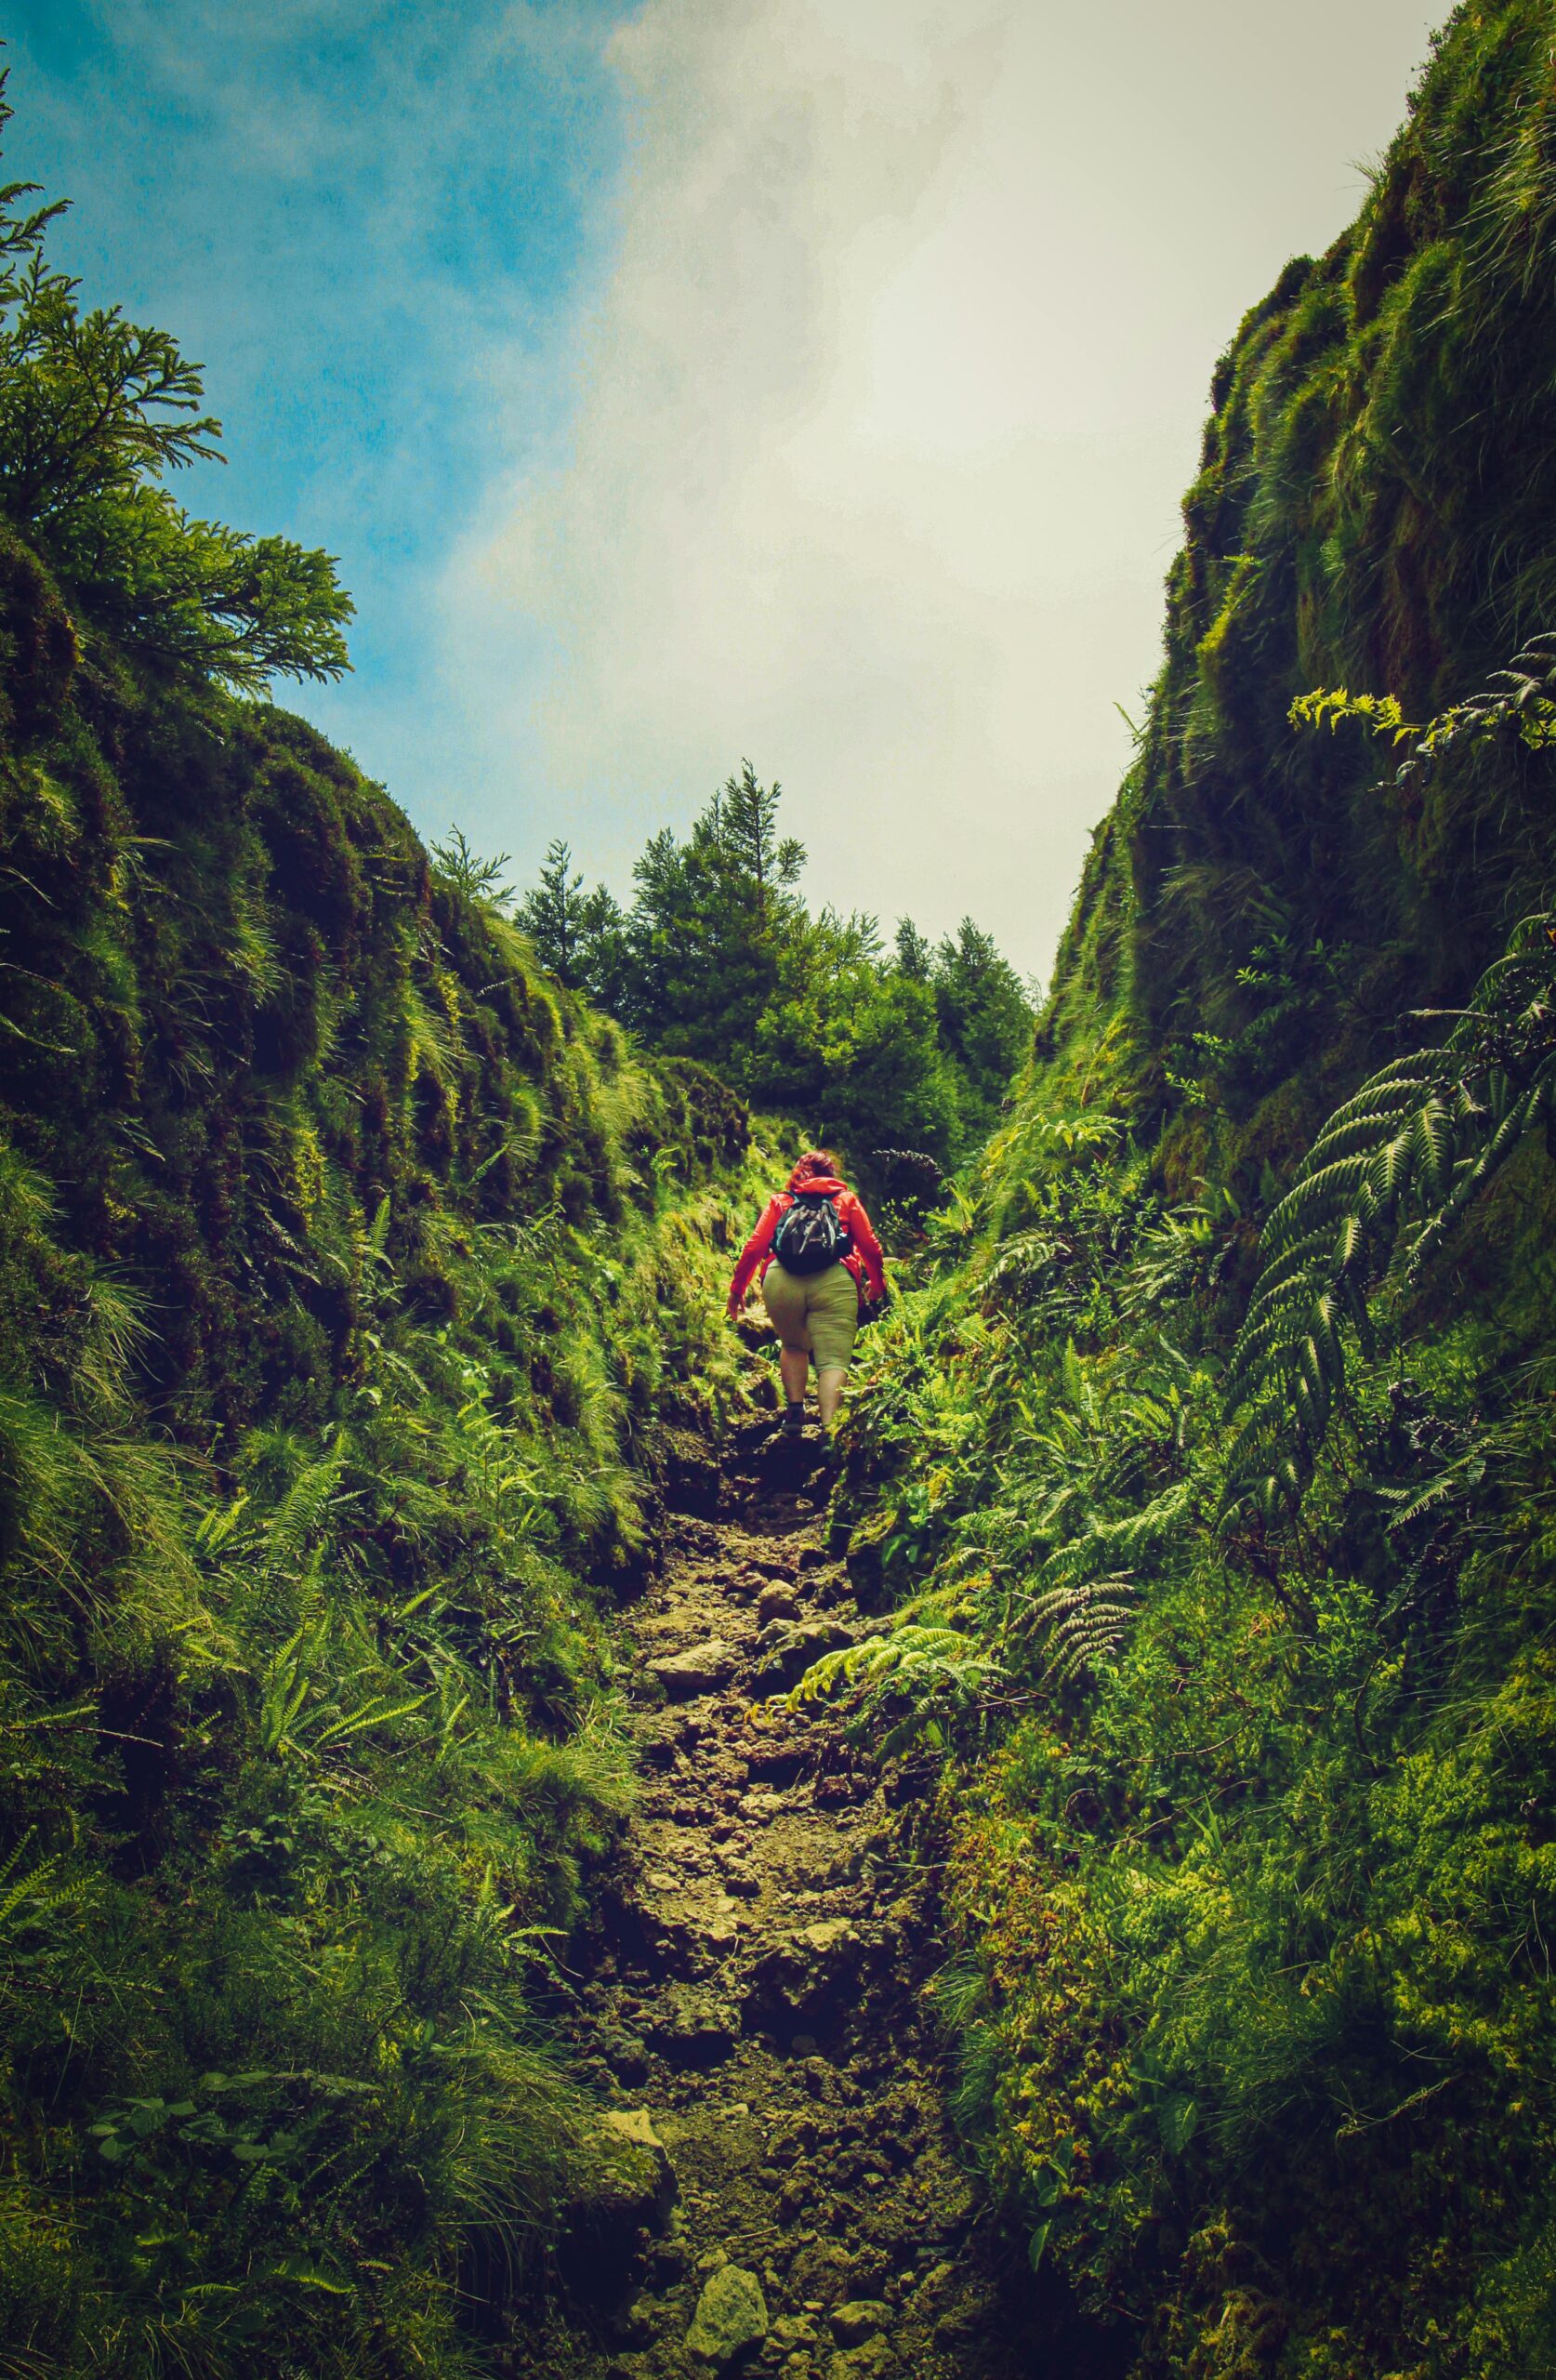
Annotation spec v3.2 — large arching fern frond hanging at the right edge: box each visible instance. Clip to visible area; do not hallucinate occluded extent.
[1225,911,1556,1518]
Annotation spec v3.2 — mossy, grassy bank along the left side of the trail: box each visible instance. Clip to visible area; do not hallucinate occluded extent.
[0,516,747,2380]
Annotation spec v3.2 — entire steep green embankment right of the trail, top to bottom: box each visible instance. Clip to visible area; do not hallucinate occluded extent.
[833,14,1556,2380]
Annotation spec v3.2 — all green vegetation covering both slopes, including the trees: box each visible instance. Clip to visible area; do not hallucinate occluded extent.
[15,0,1556,2380]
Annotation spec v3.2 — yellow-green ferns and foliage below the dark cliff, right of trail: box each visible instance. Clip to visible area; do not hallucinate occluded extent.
[837,880,1556,2380]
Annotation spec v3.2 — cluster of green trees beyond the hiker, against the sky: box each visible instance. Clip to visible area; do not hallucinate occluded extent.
[519,761,1033,1175]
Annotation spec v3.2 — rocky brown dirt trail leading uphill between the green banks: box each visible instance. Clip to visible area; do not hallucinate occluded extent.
[514,1416,1073,2380]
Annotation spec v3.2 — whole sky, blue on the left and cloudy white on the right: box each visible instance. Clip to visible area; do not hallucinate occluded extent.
[5,0,1434,976]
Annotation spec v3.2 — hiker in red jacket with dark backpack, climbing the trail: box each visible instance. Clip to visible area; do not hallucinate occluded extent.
[728,1149,885,1437]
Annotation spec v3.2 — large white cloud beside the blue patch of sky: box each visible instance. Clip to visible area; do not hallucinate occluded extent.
[447,0,1425,966]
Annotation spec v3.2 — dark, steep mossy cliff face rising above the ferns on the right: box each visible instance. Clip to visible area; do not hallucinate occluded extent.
[1042,0,1556,1180]
